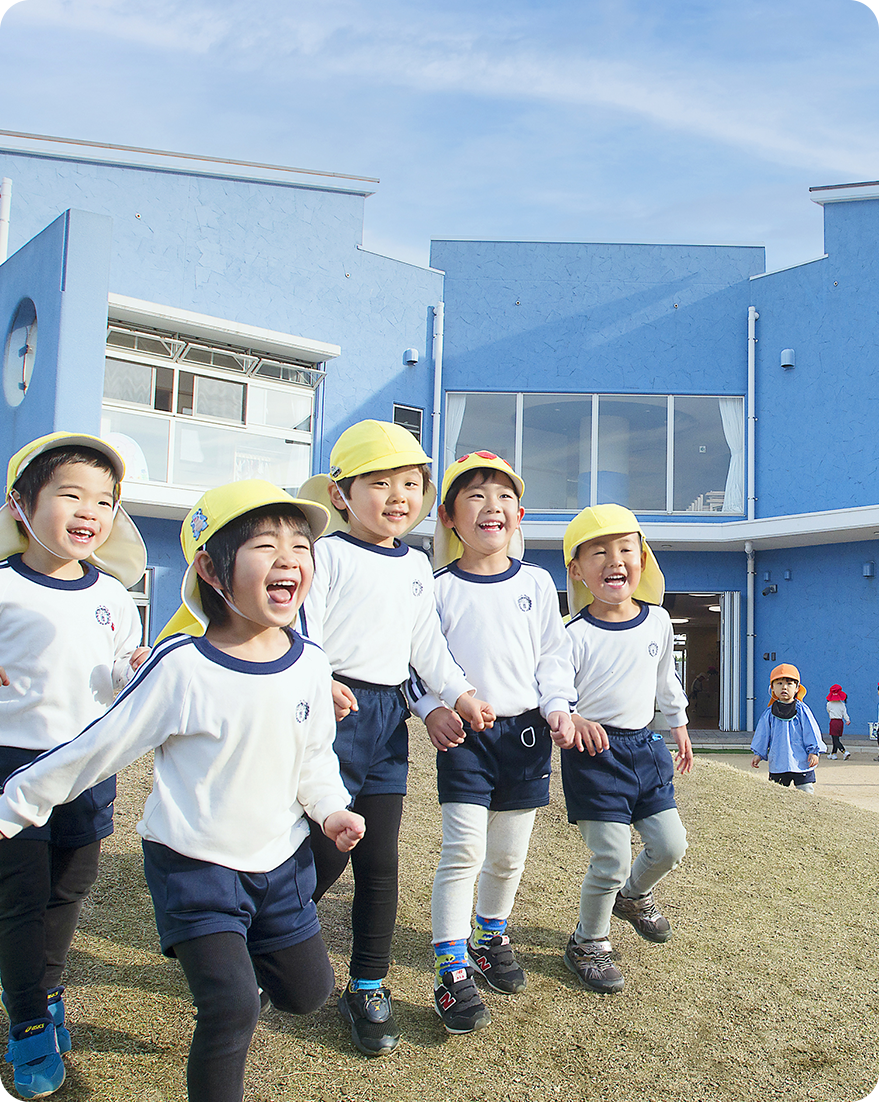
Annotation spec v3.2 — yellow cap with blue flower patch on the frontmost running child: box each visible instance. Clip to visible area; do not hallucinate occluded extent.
[156,478,329,642]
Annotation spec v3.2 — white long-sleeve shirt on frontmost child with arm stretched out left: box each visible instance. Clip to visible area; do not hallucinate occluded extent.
[0,633,350,873]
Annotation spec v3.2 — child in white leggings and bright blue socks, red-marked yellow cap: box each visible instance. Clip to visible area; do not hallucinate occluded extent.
[410,452,574,1034]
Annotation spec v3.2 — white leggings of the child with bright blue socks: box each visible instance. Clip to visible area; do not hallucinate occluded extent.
[431,803,536,942]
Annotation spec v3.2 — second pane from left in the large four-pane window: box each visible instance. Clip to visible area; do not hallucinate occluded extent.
[521,395,593,511]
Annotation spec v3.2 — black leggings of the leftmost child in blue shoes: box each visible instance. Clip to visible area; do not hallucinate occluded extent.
[0,838,100,1024]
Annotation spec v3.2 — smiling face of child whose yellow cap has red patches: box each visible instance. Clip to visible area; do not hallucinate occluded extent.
[440,471,524,570]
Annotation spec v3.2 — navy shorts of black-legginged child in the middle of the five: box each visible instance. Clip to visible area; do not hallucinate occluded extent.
[333,673,409,799]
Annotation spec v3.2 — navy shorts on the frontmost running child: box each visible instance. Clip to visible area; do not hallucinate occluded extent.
[143,838,321,957]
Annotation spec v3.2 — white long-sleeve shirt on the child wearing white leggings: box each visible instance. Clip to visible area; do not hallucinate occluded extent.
[408,560,576,720]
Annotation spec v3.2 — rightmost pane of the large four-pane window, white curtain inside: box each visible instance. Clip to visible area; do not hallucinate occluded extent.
[674,398,745,512]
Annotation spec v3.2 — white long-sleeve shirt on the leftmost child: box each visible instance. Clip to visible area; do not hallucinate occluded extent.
[0,554,143,750]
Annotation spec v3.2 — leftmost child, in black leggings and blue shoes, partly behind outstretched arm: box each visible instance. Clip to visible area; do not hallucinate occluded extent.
[0,432,149,1098]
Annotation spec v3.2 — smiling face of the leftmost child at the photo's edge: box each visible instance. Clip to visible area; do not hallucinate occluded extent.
[11,463,116,576]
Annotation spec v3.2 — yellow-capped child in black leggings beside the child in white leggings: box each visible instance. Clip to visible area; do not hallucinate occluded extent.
[300,421,493,1056]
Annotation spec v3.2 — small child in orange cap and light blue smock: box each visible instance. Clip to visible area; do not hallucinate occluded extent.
[751,663,827,796]
